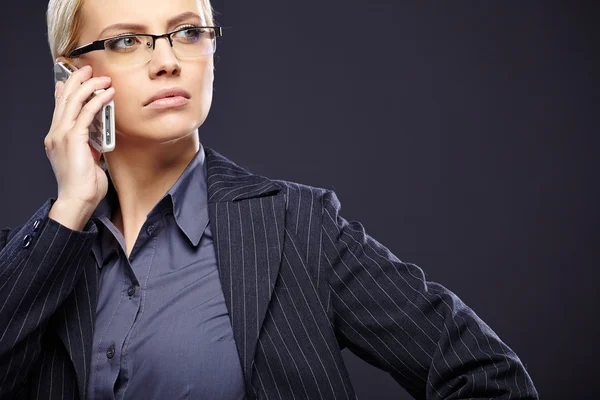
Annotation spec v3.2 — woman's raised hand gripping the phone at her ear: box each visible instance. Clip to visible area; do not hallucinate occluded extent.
[44,66,114,229]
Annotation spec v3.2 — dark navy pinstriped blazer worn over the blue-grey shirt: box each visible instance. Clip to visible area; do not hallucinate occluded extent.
[0,148,538,400]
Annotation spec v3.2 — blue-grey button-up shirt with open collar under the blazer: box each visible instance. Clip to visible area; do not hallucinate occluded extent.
[87,146,244,399]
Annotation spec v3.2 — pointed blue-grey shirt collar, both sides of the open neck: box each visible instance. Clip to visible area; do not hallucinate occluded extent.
[92,144,209,246]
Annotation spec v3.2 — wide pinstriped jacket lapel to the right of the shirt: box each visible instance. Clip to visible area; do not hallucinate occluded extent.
[205,148,286,390]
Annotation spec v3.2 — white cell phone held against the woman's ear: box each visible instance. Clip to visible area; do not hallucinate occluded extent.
[54,62,116,153]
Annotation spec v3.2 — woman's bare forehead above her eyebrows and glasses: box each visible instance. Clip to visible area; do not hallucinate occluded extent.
[81,0,205,37]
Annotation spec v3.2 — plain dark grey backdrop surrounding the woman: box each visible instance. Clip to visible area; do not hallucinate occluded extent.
[0,0,600,399]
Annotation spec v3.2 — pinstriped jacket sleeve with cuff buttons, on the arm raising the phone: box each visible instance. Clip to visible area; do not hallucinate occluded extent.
[0,199,97,398]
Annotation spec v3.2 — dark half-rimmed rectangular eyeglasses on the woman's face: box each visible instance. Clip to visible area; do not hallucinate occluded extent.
[68,26,223,65]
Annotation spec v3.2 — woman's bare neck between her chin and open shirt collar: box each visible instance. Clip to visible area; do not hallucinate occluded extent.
[105,131,200,247]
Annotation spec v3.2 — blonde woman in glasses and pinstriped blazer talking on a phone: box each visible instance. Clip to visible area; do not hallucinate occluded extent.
[0,0,537,399]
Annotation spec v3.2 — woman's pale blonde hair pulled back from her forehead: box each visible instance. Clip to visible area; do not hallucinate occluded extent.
[46,0,214,60]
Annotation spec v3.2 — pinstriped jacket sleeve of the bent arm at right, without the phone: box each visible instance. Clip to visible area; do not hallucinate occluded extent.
[322,191,538,400]
